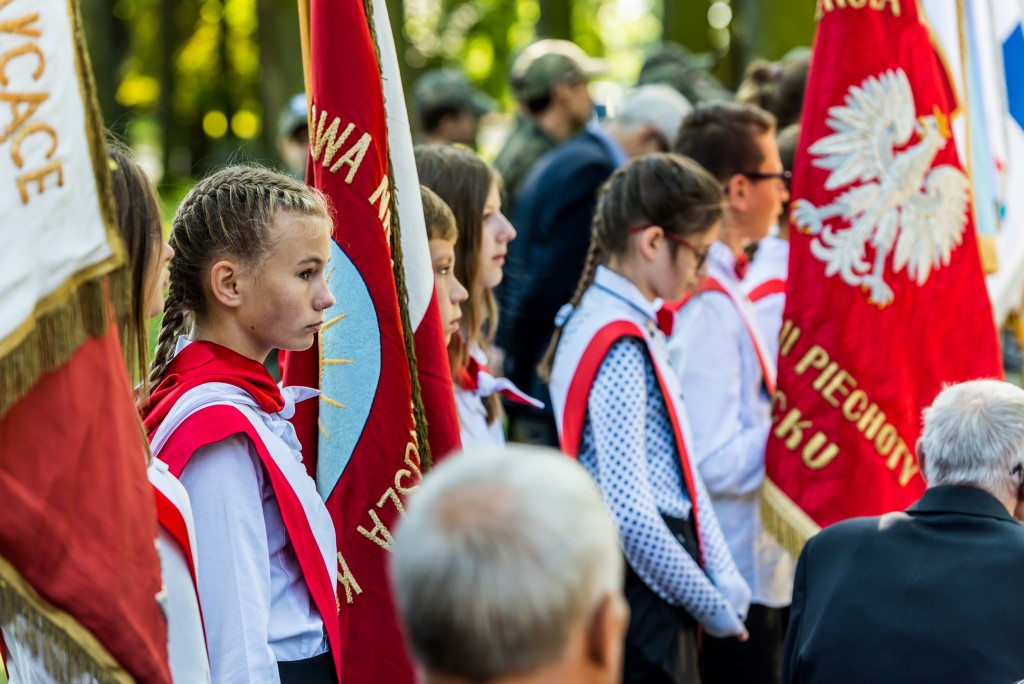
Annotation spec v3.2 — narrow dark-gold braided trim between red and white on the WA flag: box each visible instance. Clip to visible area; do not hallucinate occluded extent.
[362,0,432,473]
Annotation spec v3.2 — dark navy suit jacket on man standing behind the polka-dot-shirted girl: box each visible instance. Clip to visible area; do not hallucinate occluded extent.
[497,130,615,414]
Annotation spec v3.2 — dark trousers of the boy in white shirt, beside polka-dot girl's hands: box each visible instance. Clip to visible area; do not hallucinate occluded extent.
[700,604,790,684]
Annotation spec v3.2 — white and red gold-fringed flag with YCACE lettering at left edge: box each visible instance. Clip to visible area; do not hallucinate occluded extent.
[0,0,171,682]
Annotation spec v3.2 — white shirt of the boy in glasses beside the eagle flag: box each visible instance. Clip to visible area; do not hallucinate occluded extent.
[669,242,795,607]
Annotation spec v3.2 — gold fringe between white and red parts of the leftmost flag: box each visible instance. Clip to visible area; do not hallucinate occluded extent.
[0,267,130,418]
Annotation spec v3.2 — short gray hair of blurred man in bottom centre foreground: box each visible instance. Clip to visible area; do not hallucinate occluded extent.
[391,446,624,681]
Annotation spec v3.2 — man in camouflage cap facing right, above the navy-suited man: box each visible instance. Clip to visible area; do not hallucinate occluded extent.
[495,39,603,206]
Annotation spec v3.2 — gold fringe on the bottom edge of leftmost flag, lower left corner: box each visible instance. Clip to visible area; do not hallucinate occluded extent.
[0,557,132,684]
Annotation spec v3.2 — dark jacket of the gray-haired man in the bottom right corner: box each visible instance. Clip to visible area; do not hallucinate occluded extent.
[782,486,1024,684]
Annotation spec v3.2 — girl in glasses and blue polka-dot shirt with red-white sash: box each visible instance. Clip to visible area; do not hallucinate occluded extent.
[540,155,751,683]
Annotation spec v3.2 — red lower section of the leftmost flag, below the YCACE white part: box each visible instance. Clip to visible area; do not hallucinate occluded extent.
[0,323,171,682]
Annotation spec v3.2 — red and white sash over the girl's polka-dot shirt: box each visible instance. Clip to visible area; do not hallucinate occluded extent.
[550,288,703,565]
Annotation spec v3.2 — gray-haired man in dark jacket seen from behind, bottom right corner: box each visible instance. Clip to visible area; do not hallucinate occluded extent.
[782,380,1024,684]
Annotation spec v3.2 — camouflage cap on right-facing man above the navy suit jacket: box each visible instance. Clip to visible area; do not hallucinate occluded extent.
[509,38,606,100]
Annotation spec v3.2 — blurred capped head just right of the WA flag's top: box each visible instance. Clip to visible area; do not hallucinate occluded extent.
[415,69,495,147]
